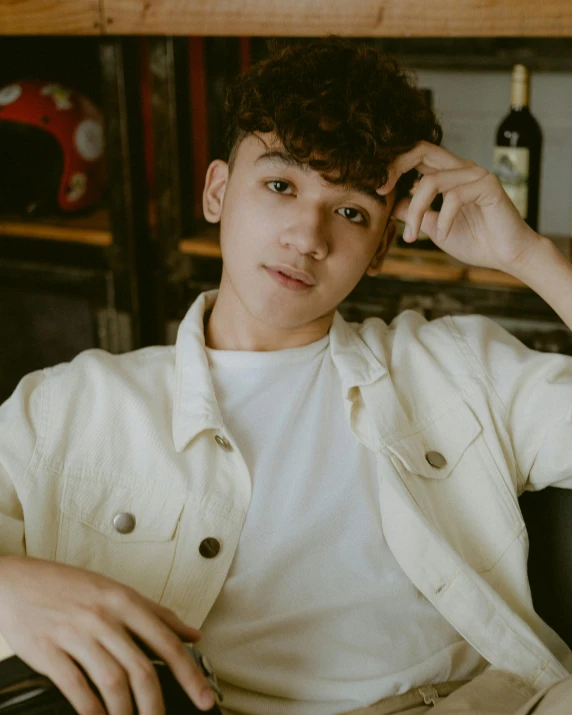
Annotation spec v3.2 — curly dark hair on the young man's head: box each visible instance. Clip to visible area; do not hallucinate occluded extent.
[225,35,443,203]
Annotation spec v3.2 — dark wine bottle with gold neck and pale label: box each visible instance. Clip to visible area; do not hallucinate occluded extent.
[493,65,542,231]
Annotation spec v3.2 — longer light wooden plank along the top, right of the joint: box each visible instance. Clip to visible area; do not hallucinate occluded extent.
[101,0,572,37]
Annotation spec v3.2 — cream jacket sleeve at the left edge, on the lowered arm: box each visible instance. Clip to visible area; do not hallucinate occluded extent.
[0,370,44,557]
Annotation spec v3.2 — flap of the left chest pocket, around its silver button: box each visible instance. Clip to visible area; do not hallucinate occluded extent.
[61,474,184,542]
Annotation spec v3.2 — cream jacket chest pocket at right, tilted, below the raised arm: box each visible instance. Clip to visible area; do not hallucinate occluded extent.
[388,402,524,571]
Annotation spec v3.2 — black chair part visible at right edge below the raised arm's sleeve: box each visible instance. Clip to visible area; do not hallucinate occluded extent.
[519,487,572,648]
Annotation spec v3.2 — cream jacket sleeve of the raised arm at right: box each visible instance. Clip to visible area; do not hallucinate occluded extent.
[451,316,572,492]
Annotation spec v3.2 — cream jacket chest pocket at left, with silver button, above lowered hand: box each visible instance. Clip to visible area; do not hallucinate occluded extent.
[56,475,184,602]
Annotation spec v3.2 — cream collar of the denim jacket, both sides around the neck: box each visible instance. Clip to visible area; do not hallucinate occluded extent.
[172,289,387,452]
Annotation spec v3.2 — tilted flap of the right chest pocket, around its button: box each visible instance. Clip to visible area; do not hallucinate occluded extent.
[387,402,483,479]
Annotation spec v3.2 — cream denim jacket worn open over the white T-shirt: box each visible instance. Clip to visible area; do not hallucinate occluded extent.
[0,291,572,688]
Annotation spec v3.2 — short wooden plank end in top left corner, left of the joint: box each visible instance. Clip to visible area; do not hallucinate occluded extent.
[0,0,101,35]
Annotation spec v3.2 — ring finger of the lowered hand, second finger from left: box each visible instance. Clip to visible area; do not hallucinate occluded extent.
[66,639,133,715]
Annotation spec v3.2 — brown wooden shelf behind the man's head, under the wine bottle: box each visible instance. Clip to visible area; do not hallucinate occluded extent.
[179,226,526,288]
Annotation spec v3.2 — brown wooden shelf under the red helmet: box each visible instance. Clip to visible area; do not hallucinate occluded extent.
[0,209,113,246]
